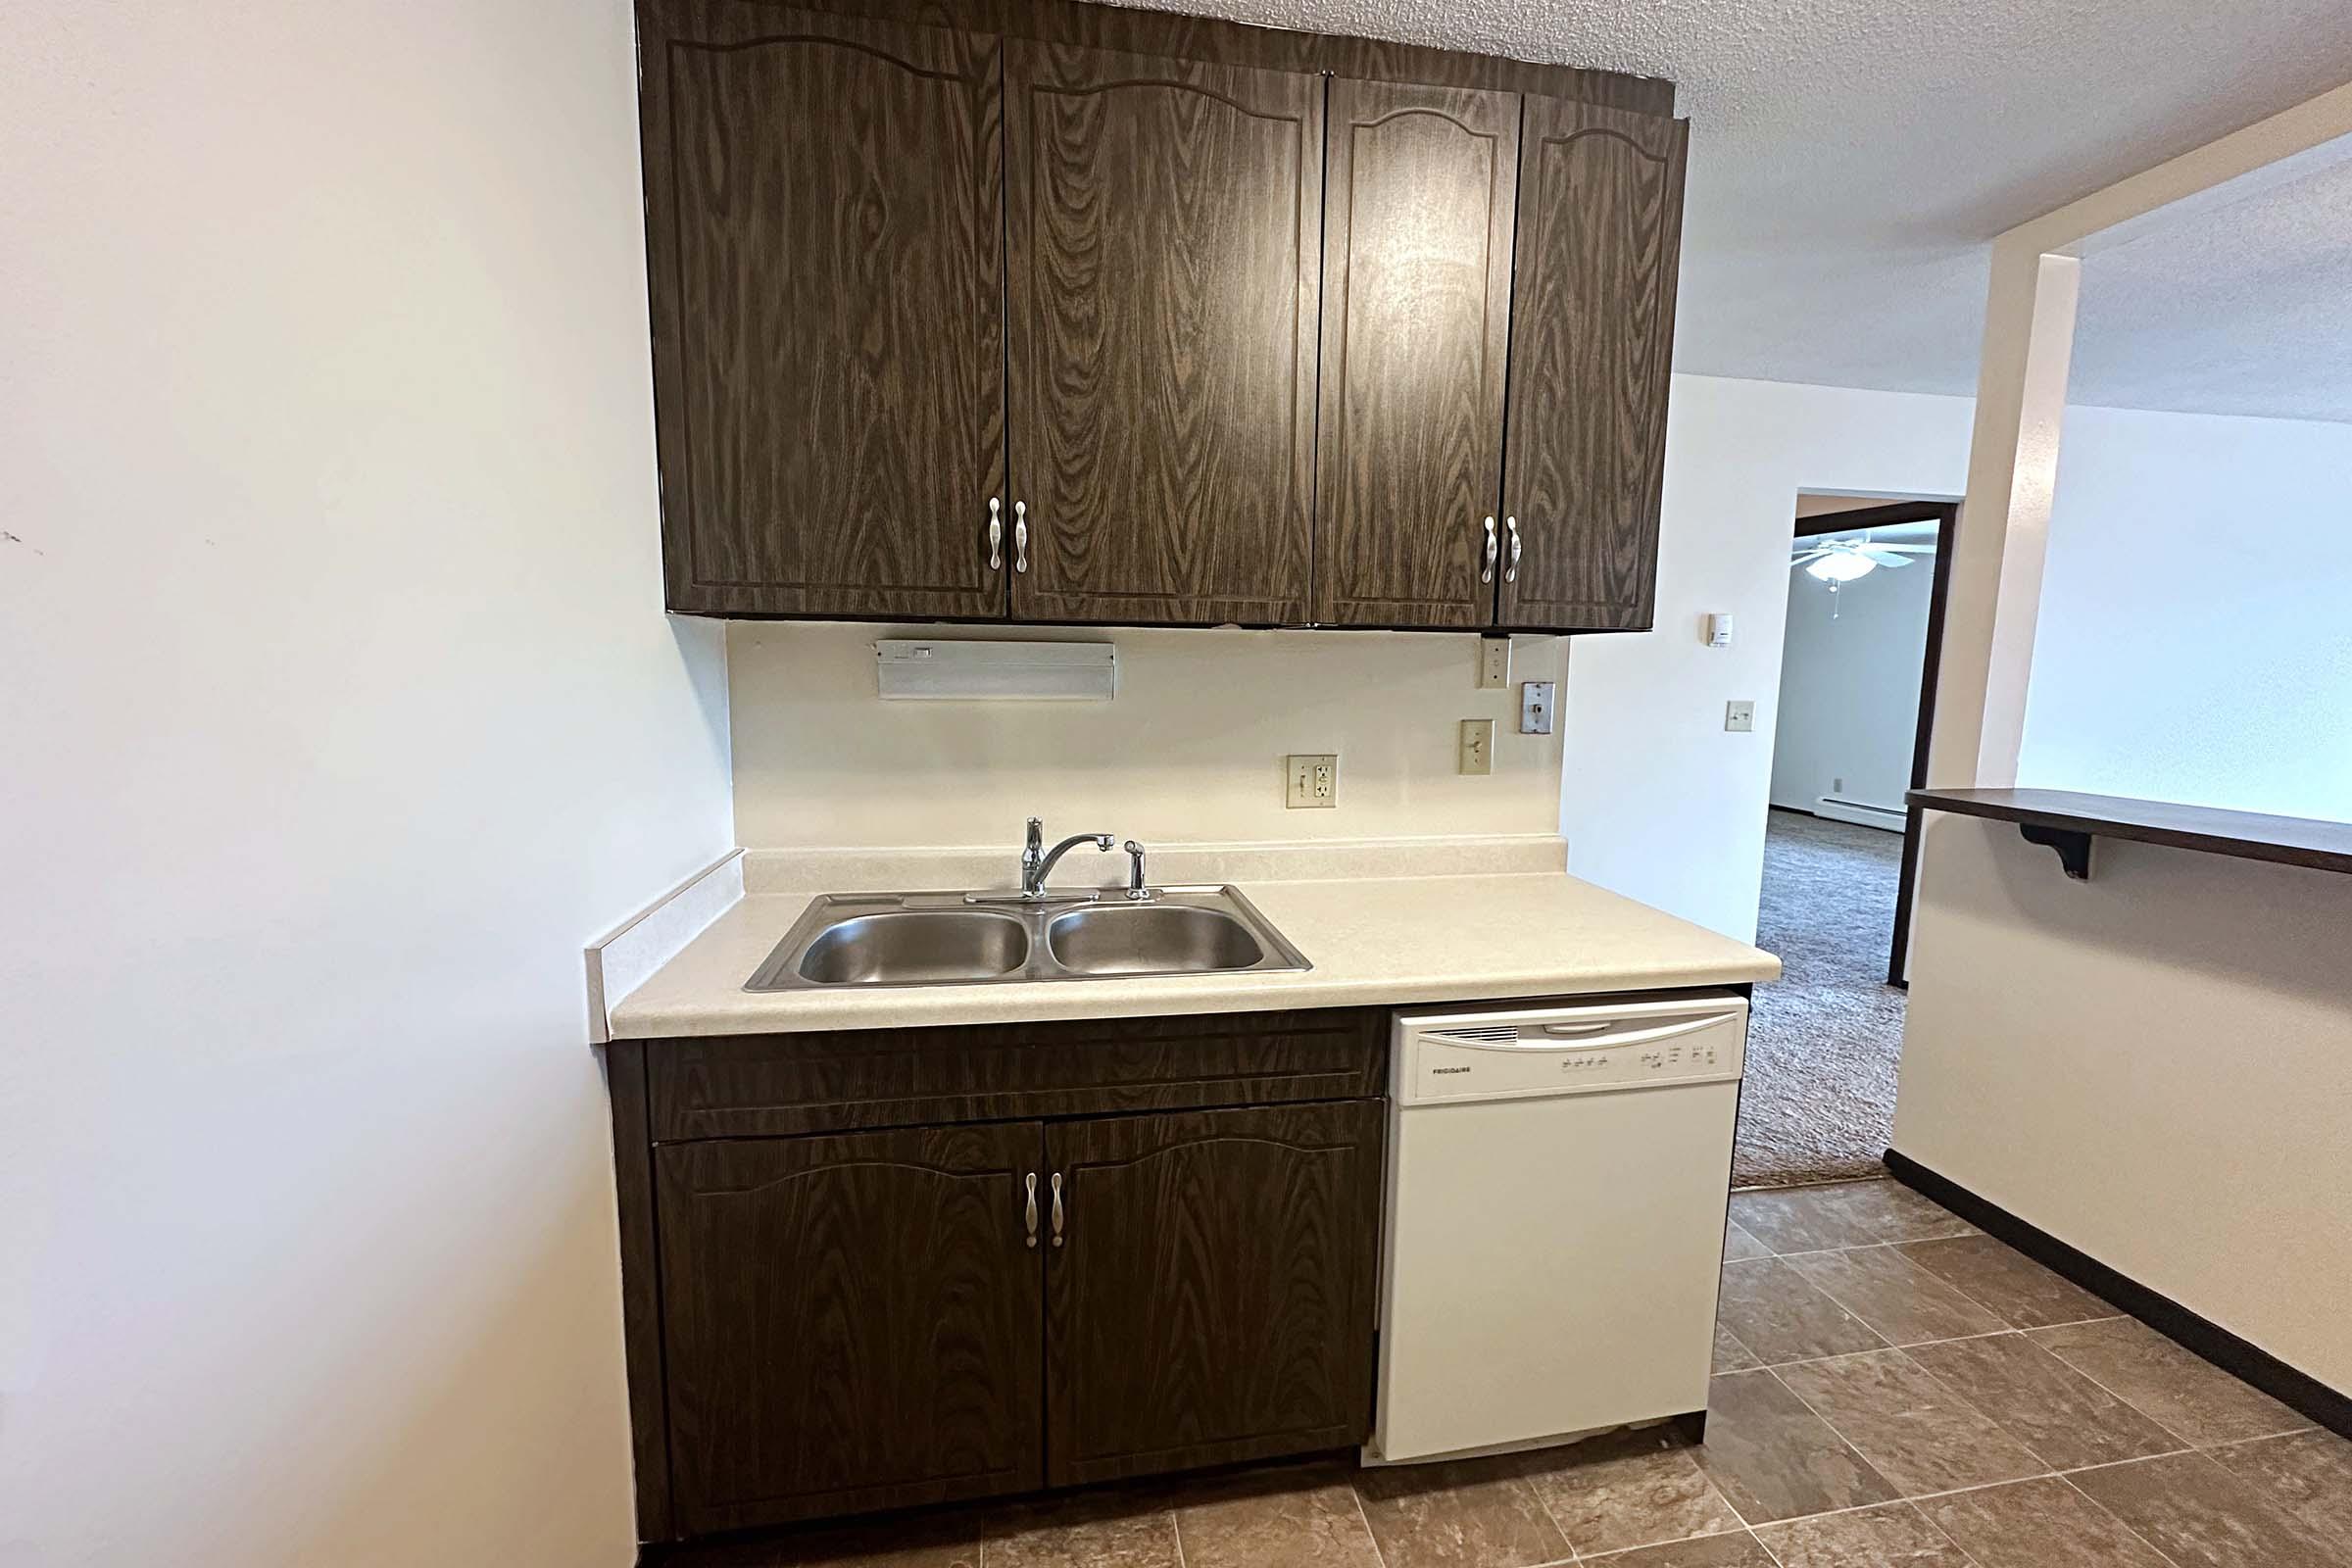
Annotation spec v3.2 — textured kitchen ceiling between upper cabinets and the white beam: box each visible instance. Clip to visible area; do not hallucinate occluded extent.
[1119,0,2352,402]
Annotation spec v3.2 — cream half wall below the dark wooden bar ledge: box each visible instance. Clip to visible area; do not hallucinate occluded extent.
[1895,817,2352,1390]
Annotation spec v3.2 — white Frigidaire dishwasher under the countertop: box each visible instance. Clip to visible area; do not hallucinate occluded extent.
[1364,992,1747,1464]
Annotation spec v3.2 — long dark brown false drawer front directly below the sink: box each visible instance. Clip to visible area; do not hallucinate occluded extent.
[647,1008,1388,1143]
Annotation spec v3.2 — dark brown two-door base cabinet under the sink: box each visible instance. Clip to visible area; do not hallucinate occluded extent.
[612,1008,1388,1540]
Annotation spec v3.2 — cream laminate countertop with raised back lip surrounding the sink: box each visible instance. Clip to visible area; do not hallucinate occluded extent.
[607,835,1781,1039]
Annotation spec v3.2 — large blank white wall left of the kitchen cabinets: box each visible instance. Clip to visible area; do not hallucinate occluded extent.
[0,0,729,1568]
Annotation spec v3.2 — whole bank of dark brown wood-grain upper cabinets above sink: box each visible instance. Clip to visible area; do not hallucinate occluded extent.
[637,0,1687,632]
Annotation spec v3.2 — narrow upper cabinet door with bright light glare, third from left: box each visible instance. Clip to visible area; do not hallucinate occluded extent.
[1315,80,1519,625]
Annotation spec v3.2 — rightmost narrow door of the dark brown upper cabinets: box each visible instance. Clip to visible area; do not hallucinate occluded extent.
[1498,96,1689,630]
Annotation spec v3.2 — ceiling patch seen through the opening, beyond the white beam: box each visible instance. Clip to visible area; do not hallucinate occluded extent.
[2068,160,2352,423]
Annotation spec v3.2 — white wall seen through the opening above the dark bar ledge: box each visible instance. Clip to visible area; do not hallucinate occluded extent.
[2018,409,2352,820]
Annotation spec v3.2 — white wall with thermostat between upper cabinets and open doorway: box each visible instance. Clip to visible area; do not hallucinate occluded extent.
[1559,376,1971,941]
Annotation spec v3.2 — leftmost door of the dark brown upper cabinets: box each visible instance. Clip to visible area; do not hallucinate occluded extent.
[637,0,1011,615]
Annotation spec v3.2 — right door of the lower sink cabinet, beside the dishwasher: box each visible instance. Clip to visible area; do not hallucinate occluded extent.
[1047,1101,1383,1486]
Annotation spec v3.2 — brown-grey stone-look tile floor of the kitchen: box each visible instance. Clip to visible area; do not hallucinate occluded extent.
[672,1183,2352,1568]
